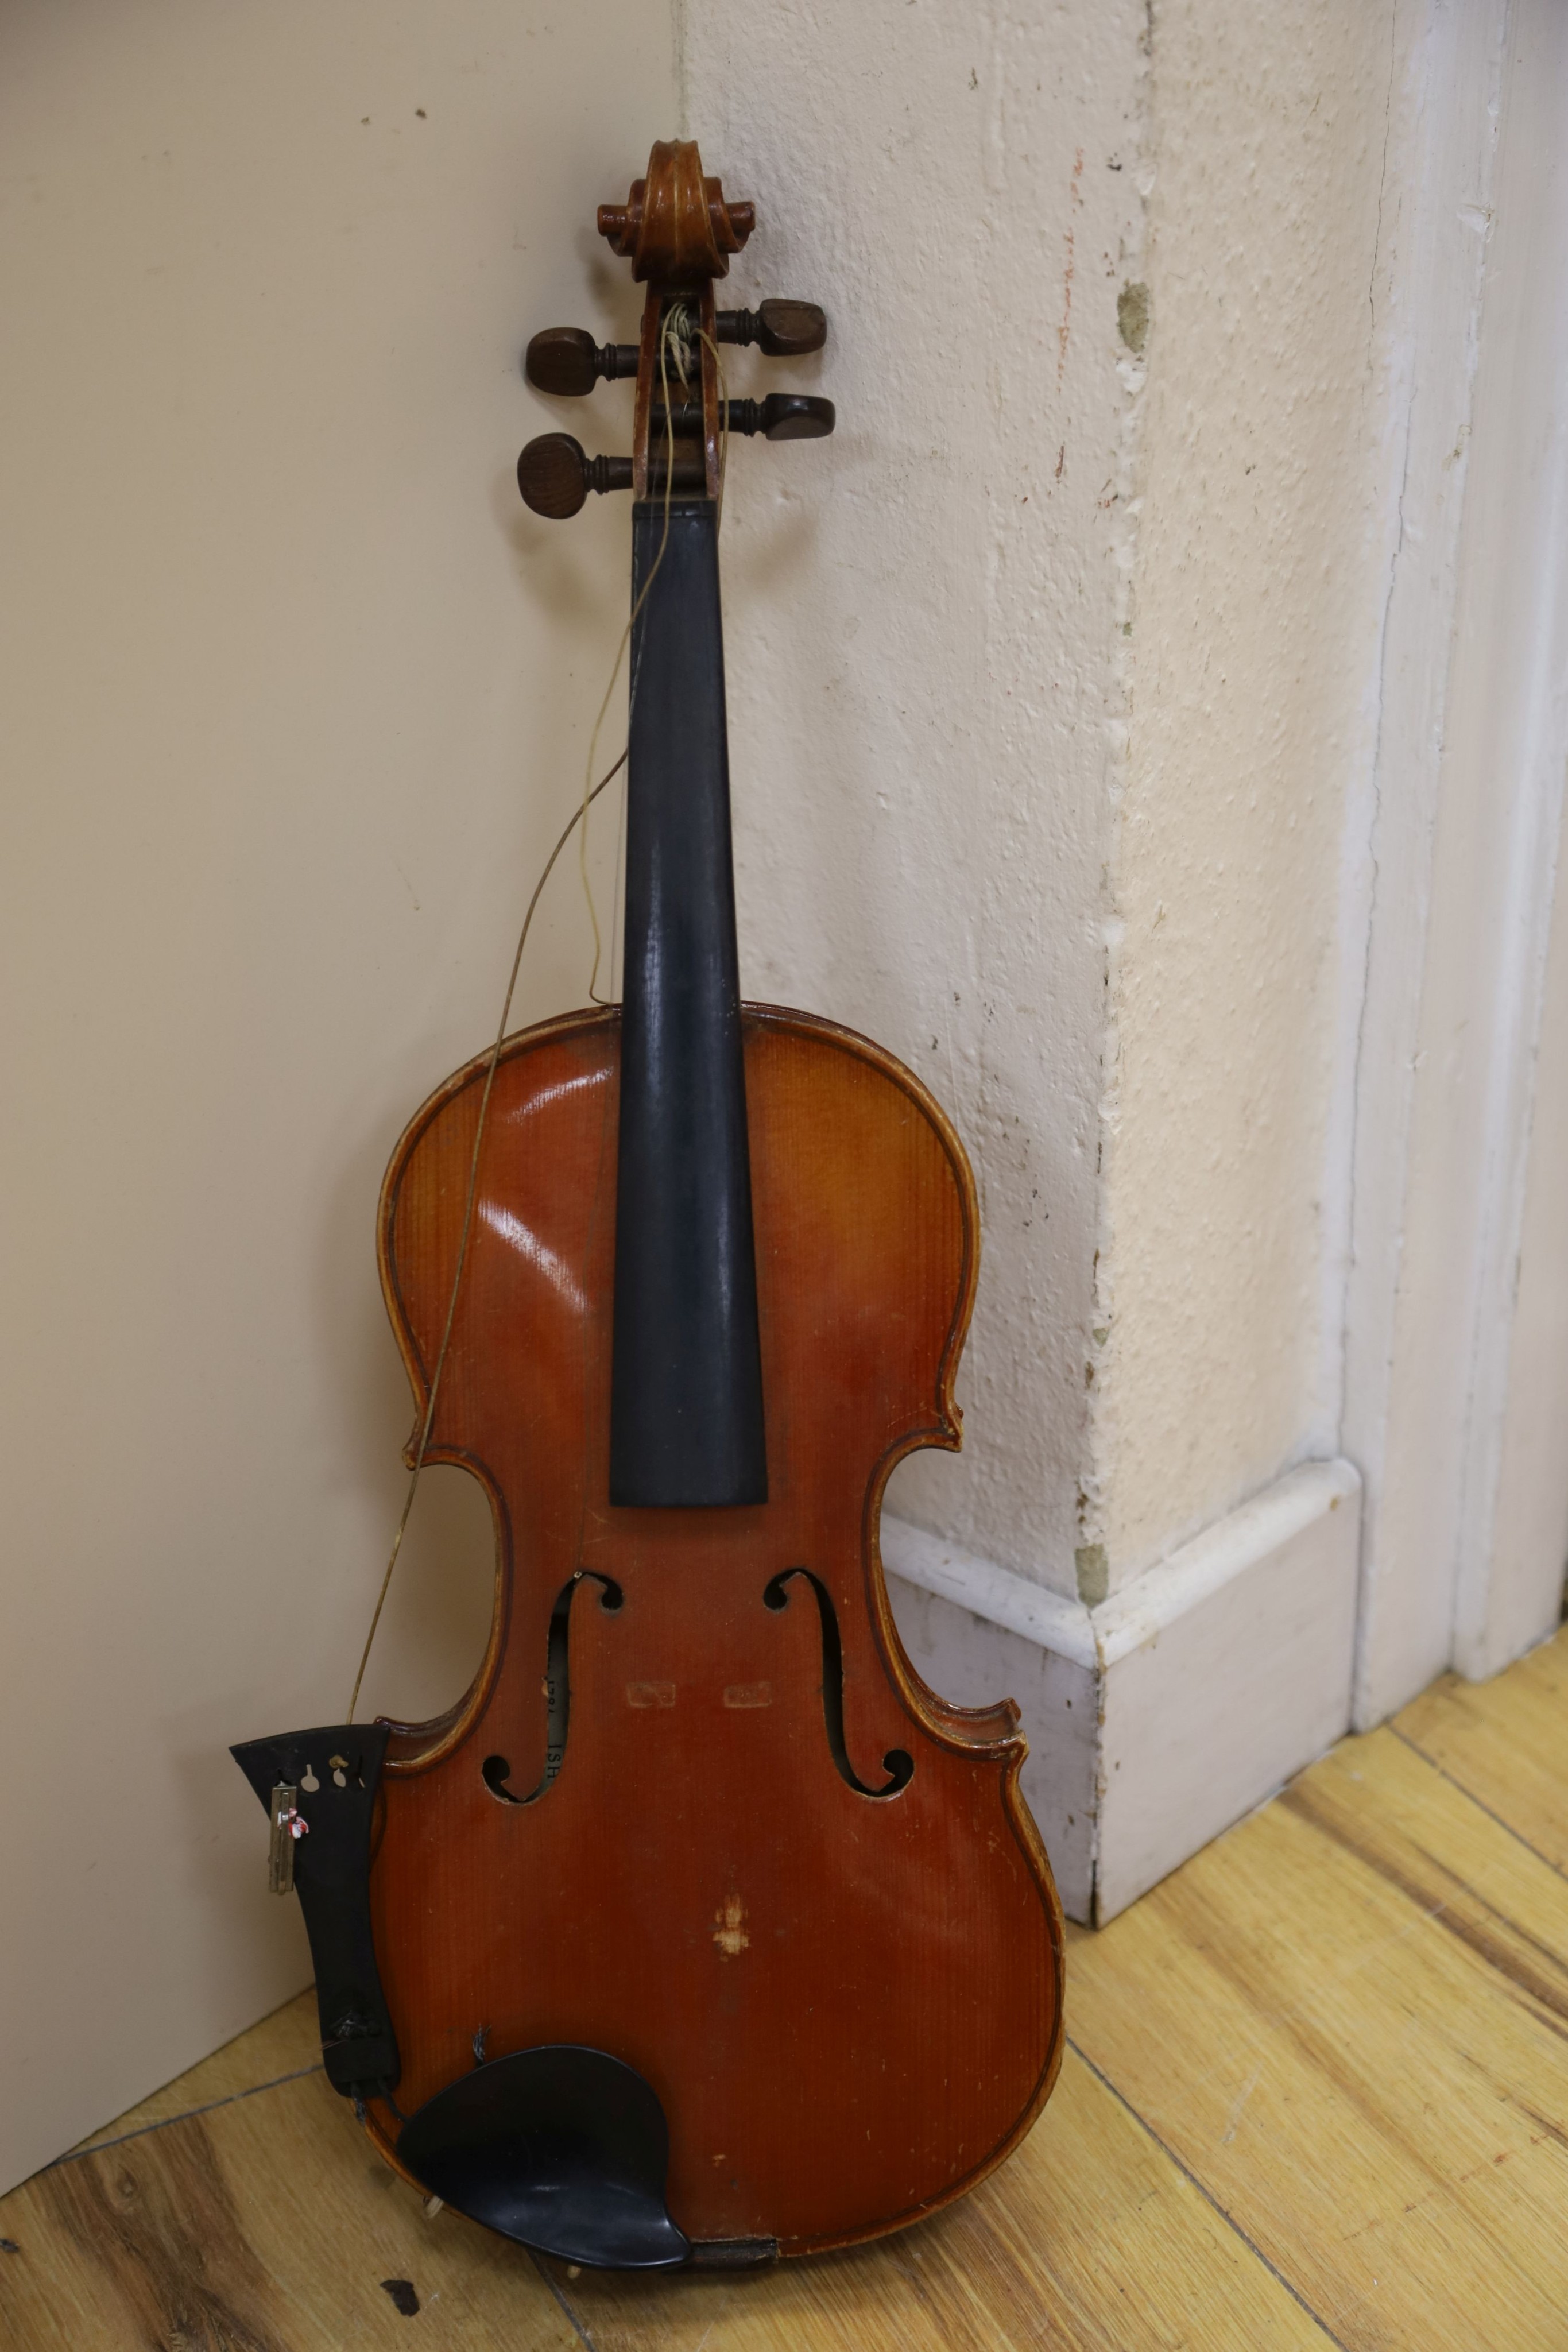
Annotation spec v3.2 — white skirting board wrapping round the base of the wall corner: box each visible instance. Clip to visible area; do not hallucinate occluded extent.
[881,1461,1361,1927]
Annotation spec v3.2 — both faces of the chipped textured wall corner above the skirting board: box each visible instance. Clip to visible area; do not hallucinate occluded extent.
[682,0,1394,1601]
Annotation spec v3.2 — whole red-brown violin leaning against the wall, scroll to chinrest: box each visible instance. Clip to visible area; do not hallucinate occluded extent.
[235,141,1063,2270]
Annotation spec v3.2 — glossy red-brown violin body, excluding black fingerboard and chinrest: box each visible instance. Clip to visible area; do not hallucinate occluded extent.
[369,1007,1060,2253]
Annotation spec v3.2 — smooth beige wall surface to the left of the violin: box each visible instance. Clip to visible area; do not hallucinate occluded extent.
[0,0,672,2185]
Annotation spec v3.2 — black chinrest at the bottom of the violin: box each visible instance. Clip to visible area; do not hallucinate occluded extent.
[397,2041,691,2270]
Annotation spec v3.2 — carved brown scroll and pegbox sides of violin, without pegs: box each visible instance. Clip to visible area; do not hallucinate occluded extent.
[599,139,757,498]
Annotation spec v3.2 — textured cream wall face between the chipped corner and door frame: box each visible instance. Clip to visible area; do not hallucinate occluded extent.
[1105,0,1392,1590]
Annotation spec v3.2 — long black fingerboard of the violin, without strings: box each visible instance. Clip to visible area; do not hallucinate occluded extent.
[609,498,766,1508]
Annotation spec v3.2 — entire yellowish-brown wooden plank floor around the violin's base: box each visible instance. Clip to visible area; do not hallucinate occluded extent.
[0,1637,1568,2352]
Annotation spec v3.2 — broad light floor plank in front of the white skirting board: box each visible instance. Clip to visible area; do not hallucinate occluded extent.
[1067,1731,1568,2352]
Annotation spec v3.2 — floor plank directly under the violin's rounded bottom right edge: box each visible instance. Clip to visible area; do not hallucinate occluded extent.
[555,2051,1326,2352]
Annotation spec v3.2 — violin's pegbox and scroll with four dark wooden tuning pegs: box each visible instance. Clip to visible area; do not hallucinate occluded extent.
[517,179,835,522]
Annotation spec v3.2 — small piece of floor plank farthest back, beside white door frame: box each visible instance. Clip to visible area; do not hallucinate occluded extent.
[1394,1630,1568,1870]
